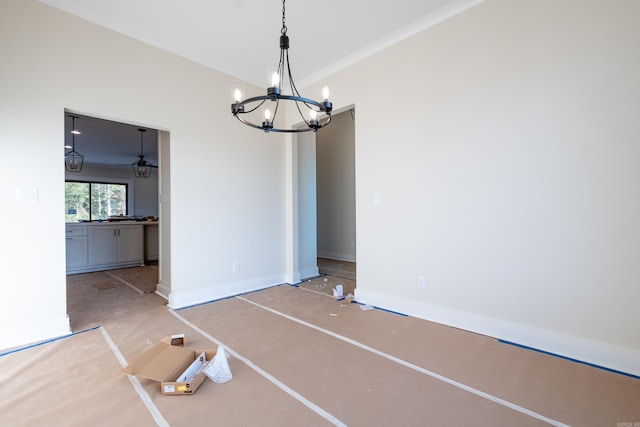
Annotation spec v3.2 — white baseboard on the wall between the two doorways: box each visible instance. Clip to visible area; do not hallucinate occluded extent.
[167,275,286,309]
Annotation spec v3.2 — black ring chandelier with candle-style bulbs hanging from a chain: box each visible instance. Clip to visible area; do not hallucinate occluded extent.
[231,0,333,132]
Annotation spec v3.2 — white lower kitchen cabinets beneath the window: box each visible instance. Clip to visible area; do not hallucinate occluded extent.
[67,224,144,274]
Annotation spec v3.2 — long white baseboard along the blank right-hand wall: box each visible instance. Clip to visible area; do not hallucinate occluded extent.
[356,288,640,376]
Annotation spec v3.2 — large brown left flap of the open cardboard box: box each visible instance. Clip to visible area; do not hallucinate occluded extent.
[124,342,194,382]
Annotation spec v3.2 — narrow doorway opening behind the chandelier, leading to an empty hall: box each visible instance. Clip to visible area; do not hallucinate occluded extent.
[296,107,356,285]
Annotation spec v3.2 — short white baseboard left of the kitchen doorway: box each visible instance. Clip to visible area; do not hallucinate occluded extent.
[0,316,71,353]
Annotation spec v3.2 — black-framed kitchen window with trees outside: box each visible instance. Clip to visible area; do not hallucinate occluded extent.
[64,181,127,222]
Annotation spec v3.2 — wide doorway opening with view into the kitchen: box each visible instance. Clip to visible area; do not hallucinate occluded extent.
[64,110,171,331]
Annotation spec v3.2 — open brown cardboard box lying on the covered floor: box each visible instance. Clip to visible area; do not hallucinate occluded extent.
[123,336,216,396]
